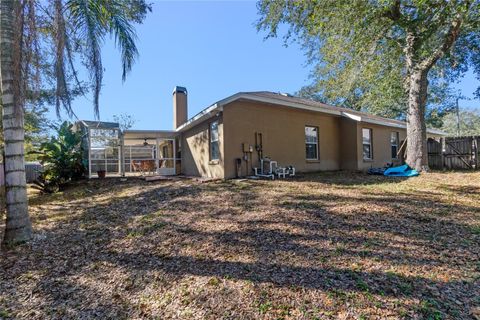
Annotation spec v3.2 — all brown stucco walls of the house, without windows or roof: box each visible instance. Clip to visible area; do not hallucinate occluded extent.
[181,101,440,179]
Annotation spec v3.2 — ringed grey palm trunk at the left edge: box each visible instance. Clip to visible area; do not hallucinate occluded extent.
[0,0,32,245]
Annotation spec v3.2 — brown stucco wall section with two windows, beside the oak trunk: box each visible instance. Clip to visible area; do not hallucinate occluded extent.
[357,122,406,170]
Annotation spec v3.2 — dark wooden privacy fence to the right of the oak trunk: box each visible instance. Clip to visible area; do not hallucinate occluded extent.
[427,136,480,170]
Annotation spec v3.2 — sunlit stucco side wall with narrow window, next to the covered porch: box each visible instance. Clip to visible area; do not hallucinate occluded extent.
[181,117,224,179]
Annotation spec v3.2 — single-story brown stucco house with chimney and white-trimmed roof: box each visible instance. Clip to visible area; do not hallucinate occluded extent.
[78,86,443,179]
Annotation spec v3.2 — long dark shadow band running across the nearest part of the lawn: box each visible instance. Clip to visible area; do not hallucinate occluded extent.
[100,252,478,305]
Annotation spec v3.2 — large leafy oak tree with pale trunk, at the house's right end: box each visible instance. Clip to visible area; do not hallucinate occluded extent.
[257,0,480,170]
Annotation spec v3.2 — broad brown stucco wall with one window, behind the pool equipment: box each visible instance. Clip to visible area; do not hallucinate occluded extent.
[223,101,341,178]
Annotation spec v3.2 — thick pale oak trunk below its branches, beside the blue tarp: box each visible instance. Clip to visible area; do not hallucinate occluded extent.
[407,70,428,171]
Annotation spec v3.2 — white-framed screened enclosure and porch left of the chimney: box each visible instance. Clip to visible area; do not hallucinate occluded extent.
[76,121,181,178]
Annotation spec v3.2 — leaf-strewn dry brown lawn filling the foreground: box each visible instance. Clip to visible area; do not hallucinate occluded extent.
[0,172,480,319]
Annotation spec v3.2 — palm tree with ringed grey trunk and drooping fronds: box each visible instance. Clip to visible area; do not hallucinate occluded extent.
[0,0,147,244]
